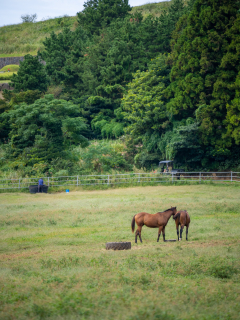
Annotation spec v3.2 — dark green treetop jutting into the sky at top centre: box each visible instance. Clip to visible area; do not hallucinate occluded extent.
[77,0,131,34]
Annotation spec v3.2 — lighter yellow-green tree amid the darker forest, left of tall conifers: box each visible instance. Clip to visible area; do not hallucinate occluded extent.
[122,55,171,168]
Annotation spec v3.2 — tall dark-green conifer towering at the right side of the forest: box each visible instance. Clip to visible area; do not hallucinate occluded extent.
[167,0,240,155]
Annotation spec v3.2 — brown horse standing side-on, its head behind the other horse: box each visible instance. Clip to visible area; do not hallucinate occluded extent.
[131,207,177,243]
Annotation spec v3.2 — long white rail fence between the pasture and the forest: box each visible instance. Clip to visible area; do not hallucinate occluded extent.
[0,171,240,190]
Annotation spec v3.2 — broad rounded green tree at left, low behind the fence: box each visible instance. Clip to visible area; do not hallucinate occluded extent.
[2,95,88,165]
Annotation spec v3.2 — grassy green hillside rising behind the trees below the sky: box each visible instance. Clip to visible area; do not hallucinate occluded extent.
[0,1,170,57]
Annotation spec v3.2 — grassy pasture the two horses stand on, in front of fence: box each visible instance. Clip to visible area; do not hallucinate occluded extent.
[0,185,240,320]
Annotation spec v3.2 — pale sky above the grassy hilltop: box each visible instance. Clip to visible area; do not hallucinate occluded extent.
[0,0,168,26]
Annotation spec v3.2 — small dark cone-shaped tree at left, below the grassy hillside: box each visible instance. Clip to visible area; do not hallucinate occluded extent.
[10,54,48,92]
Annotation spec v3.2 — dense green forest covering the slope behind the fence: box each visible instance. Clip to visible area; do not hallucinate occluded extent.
[0,0,240,175]
